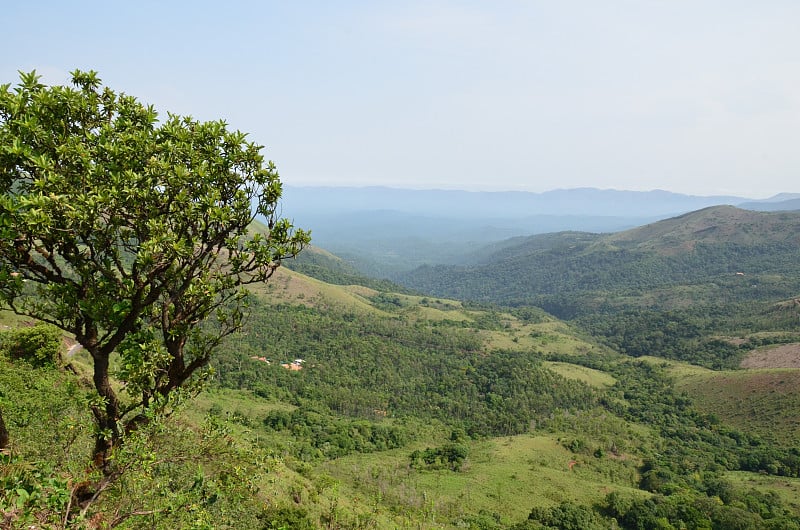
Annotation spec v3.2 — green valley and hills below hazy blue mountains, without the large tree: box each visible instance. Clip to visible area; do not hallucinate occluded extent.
[0,200,800,530]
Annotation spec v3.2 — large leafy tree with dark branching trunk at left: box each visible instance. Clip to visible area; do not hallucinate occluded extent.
[0,70,309,470]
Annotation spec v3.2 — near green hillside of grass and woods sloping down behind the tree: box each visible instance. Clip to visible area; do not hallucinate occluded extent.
[6,264,800,529]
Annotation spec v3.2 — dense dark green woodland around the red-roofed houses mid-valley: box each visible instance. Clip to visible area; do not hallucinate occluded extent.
[214,301,595,436]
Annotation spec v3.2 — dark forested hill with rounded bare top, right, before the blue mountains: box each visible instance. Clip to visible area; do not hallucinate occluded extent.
[397,206,800,367]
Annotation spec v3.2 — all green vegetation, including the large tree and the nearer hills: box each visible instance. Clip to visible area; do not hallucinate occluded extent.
[0,72,800,530]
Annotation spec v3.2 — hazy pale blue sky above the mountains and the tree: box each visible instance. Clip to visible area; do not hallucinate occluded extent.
[0,0,800,198]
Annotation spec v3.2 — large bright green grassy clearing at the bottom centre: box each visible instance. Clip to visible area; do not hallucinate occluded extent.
[322,434,646,528]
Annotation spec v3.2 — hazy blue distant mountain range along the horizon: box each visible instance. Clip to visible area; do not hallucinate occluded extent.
[282,186,800,277]
